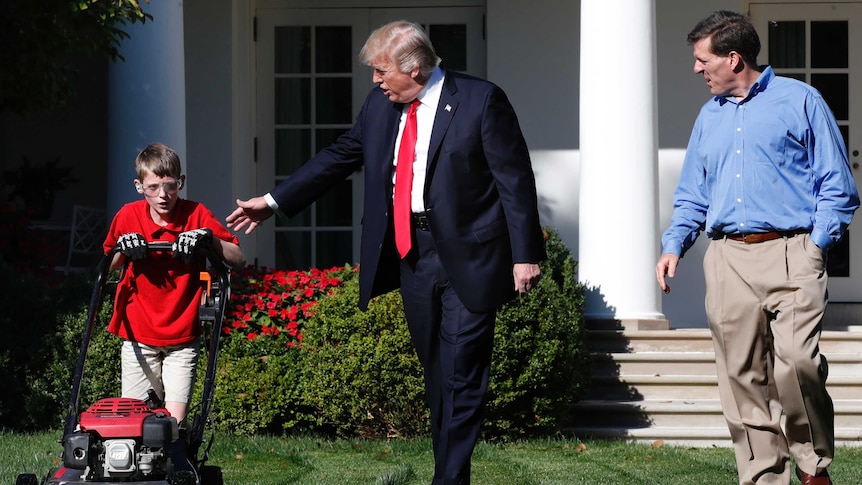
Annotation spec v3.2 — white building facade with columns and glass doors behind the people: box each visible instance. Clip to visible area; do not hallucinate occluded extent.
[79,0,862,328]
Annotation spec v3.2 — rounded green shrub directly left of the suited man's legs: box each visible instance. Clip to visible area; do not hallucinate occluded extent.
[300,286,428,437]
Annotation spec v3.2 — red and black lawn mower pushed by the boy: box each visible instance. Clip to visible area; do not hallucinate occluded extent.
[15,242,230,485]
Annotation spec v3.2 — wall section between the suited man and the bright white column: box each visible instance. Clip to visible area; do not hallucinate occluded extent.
[487,0,580,284]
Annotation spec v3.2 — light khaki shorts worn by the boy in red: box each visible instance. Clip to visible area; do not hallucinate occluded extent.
[122,340,200,403]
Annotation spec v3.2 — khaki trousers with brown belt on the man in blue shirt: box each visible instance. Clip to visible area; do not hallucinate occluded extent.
[703,234,835,485]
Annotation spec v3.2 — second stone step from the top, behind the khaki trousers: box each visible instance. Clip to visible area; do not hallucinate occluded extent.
[592,352,862,376]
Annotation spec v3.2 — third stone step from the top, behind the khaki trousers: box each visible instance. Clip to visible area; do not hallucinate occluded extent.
[588,374,862,401]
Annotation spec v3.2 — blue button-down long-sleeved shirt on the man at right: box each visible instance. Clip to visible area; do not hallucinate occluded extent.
[662,66,859,256]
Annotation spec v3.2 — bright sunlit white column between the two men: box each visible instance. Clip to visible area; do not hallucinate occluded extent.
[578,0,667,328]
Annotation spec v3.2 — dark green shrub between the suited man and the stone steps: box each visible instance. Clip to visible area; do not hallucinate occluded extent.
[484,229,590,439]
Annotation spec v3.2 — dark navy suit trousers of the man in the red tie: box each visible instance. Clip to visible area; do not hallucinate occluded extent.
[401,230,496,485]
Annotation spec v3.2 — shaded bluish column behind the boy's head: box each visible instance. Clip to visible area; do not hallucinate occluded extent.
[107,0,186,217]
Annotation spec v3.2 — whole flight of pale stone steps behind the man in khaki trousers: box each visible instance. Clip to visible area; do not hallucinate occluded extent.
[580,326,862,447]
